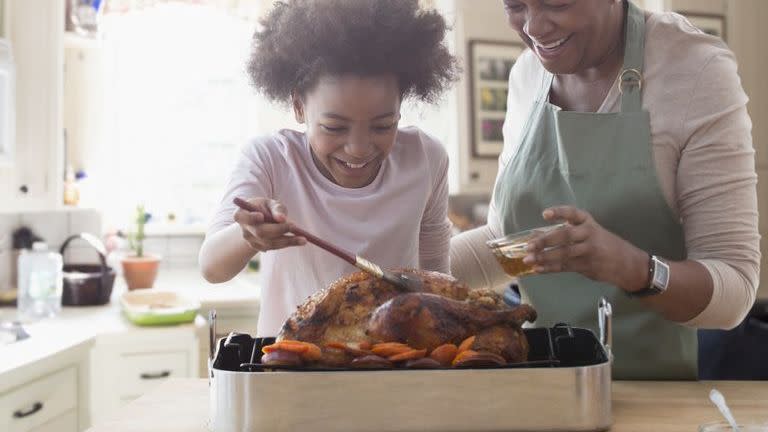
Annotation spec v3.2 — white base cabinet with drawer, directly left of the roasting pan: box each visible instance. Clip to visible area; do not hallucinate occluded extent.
[91,325,199,424]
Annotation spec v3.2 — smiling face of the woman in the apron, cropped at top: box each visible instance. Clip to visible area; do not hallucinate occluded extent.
[503,0,623,74]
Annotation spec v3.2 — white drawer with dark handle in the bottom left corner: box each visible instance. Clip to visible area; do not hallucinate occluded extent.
[0,367,77,432]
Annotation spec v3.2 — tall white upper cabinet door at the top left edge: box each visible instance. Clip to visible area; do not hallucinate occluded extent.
[0,0,65,211]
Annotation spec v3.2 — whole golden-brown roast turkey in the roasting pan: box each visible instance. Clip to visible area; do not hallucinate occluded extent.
[277,270,536,366]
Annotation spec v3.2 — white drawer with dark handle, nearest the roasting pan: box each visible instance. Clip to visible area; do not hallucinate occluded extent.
[117,351,189,400]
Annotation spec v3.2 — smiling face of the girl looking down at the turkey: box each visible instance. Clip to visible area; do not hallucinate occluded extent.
[293,75,400,188]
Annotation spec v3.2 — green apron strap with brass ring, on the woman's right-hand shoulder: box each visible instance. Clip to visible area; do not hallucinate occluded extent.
[618,0,645,112]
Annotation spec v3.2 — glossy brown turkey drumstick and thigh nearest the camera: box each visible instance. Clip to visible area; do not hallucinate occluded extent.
[368,293,536,362]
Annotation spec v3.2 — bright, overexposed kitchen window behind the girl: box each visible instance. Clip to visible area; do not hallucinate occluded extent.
[85,2,450,232]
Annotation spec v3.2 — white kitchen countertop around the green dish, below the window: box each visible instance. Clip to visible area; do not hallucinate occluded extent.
[0,268,259,384]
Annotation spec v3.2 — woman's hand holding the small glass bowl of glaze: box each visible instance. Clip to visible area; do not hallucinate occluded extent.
[523,206,648,292]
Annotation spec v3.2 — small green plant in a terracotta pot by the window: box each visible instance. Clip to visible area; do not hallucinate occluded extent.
[122,205,160,290]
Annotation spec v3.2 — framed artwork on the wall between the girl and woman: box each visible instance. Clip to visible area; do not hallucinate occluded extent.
[468,40,525,159]
